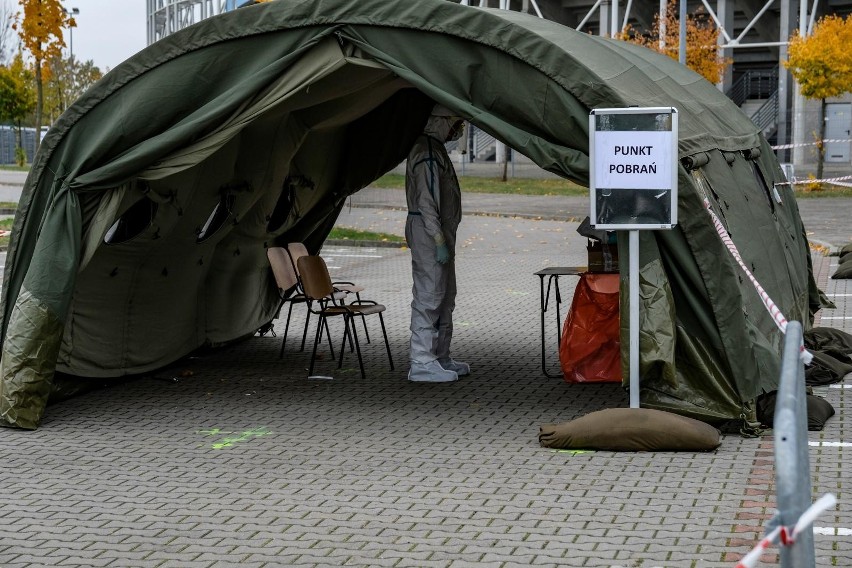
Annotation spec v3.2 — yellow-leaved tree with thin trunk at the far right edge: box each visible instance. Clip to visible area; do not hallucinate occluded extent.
[784,15,852,179]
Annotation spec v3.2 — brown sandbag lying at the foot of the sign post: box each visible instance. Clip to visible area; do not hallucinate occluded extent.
[538,408,722,452]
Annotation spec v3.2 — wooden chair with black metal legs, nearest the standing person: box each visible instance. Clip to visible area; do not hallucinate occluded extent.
[297,255,394,378]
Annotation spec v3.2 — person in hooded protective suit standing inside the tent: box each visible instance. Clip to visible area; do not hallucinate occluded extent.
[405,105,470,383]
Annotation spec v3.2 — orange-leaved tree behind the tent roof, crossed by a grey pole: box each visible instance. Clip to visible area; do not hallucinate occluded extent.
[619,0,731,83]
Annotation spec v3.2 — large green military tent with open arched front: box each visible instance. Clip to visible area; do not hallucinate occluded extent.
[0,0,818,428]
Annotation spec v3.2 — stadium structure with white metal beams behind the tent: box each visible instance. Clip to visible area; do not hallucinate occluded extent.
[147,0,852,181]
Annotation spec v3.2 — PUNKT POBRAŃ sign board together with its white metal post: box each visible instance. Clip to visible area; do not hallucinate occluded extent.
[589,107,678,408]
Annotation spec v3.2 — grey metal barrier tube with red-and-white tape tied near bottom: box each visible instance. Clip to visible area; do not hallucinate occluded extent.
[773,321,816,568]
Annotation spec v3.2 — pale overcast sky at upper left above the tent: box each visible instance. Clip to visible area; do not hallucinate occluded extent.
[60,0,147,72]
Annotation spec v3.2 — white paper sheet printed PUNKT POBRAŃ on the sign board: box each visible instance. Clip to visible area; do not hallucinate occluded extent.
[595,131,672,189]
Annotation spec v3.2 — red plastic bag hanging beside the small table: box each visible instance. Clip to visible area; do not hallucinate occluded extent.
[559,272,621,383]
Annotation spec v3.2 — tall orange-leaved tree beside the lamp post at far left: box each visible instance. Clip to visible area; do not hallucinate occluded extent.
[14,0,77,151]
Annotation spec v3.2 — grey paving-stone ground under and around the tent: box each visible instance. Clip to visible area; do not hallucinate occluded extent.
[0,185,852,568]
